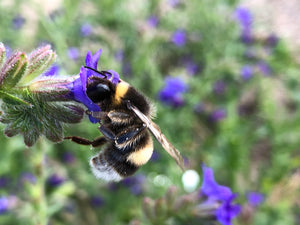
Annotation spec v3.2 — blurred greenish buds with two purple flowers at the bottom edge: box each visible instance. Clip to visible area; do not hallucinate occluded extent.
[143,165,241,225]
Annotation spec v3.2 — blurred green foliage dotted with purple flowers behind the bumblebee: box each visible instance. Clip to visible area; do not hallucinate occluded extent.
[0,0,300,225]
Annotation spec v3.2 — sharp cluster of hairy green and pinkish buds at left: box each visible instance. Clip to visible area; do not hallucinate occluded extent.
[0,43,84,146]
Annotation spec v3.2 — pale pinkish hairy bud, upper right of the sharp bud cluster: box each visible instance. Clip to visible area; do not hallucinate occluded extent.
[26,45,56,81]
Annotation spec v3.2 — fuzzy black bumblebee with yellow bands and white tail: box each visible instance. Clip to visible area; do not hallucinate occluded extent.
[65,67,184,181]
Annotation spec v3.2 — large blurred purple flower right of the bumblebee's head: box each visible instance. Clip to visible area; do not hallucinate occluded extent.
[159,77,188,107]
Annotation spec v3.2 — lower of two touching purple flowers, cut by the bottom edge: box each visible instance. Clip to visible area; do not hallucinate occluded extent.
[215,194,241,225]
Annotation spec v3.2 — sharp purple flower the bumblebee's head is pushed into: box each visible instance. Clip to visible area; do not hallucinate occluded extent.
[68,49,119,123]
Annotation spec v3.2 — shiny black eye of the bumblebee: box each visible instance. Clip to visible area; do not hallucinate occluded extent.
[86,83,111,103]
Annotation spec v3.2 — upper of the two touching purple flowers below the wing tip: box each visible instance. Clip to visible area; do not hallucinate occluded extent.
[201,165,232,201]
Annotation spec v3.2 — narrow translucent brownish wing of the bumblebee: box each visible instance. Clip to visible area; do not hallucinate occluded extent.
[128,103,184,170]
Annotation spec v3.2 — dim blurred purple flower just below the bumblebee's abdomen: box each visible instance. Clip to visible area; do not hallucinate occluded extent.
[122,174,146,195]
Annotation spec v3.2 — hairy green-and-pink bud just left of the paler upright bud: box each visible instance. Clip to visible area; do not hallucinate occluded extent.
[0,51,28,88]
